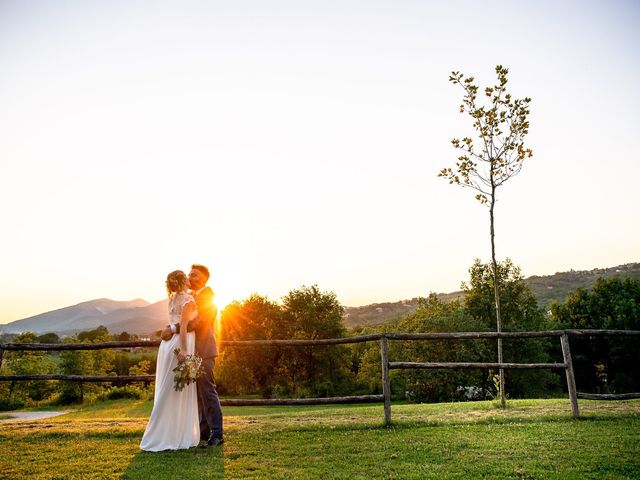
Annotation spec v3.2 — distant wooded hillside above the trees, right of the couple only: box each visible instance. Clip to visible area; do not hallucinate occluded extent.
[345,263,640,329]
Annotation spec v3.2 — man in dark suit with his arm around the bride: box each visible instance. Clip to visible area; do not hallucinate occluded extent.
[161,264,224,448]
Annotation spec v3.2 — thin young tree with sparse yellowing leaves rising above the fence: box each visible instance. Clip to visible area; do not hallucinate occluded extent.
[438,65,533,407]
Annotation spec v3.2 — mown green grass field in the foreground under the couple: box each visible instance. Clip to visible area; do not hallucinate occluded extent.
[0,400,640,480]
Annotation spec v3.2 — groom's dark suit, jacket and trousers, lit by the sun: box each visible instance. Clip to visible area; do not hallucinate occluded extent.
[176,287,222,440]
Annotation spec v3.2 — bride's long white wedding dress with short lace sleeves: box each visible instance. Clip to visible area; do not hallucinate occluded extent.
[140,293,200,452]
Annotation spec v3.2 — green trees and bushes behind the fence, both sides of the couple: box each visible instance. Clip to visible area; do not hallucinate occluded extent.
[0,260,640,408]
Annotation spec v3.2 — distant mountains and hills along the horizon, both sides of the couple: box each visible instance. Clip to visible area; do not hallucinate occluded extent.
[0,263,640,336]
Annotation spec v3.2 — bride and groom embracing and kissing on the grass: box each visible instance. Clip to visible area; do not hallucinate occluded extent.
[140,265,224,452]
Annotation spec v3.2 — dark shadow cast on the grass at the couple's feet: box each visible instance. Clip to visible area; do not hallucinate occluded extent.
[120,445,224,480]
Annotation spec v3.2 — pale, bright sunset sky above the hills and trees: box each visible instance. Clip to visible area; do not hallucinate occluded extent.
[0,0,640,323]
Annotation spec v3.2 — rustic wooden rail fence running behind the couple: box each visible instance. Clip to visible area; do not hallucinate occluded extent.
[0,330,640,424]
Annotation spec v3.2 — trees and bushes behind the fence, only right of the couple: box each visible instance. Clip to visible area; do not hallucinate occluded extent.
[219,260,640,402]
